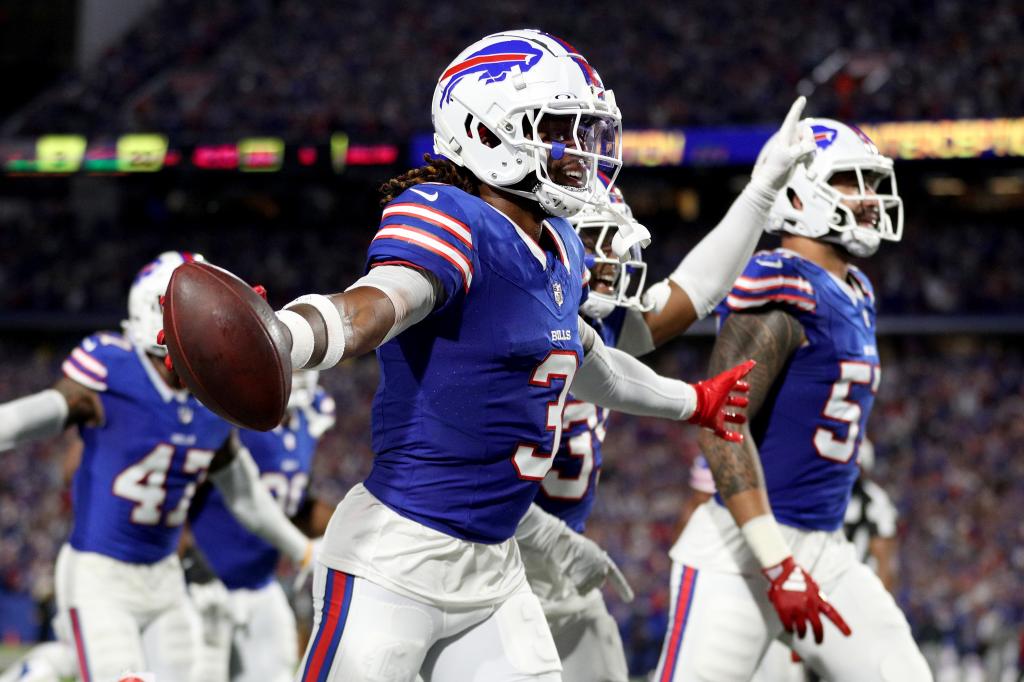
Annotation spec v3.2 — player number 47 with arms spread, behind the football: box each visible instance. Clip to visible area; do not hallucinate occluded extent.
[0,252,311,682]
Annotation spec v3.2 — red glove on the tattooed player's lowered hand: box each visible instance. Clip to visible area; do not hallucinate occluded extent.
[762,556,851,644]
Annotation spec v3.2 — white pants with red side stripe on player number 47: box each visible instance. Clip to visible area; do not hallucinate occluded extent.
[55,545,200,682]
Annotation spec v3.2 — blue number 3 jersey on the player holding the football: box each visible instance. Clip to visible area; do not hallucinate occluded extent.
[366,183,585,543]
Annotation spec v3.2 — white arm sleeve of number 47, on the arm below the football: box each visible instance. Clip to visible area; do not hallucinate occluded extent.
[210,434,309,563]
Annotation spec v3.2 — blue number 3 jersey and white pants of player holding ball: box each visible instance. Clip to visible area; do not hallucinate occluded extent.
[302,183,586,680]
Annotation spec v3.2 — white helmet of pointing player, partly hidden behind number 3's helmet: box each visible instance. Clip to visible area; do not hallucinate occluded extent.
[569,174,651,319]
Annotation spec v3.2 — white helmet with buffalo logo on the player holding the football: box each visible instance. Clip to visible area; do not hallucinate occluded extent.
[431,29,623,217]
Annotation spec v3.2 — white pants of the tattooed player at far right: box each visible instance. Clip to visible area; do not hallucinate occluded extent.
[652,500,932,682]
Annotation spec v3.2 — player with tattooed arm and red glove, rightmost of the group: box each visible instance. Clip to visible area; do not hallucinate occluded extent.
[655,119,931,682]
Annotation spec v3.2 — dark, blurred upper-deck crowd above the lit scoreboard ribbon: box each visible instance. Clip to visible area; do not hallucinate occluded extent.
[8,0,1024,139]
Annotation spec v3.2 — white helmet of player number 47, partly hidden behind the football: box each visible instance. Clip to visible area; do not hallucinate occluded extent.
[121,251,203,357]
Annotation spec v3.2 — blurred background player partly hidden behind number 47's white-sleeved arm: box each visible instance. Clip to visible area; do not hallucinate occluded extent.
[188,371,335,682]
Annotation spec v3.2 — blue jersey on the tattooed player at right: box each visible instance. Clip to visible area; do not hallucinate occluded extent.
[717,249,882,530]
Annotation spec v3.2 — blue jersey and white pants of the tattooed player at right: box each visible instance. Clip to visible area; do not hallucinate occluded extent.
[653,249,929,682]
